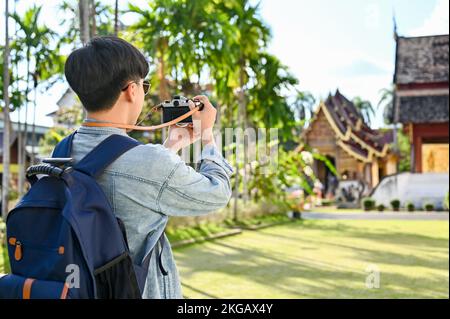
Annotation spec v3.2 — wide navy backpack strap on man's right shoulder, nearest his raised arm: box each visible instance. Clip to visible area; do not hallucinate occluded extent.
[74,134,142,178]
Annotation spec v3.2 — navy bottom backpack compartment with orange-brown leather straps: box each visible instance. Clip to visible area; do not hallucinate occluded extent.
[0,274,69,299]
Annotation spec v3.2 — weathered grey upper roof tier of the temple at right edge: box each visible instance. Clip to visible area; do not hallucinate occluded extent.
[394,34,449,84]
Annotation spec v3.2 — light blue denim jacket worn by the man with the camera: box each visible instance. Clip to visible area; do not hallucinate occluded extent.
[71,126,236,299]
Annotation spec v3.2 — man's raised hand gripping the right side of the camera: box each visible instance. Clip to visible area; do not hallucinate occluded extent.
[189,95,217,145]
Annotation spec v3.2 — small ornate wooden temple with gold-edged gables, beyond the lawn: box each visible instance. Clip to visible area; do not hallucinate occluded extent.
[303,90,398,195]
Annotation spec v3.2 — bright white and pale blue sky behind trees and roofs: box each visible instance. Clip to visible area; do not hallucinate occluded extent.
[0,0,449,127]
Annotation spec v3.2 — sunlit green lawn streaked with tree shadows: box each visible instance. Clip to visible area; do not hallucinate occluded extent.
[174,220,449,298]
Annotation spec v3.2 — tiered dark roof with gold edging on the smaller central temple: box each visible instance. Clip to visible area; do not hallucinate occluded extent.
[305,90,391,162]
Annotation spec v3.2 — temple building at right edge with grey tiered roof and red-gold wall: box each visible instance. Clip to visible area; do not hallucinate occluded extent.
[394,35,449,173]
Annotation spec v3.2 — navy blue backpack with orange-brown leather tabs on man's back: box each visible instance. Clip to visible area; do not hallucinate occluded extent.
[0,131,158,299]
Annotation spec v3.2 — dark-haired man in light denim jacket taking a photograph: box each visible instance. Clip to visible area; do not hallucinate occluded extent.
[65,37,232,298]
